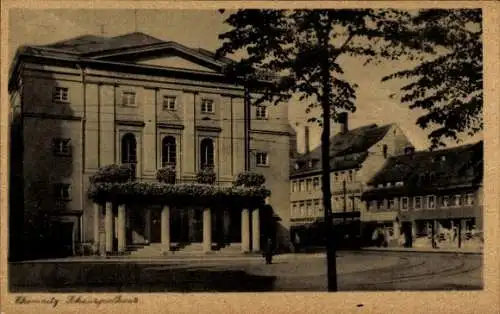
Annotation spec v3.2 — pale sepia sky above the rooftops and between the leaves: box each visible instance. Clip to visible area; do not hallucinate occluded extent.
[9,9,482,151]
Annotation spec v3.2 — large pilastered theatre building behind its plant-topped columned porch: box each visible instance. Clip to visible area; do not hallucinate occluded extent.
[9,33,293,258]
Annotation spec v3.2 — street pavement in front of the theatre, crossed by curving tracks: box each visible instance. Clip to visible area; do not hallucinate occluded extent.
[9,251,483,292]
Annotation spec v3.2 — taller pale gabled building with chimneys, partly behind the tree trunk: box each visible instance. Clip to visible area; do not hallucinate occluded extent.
[290,114,411,245]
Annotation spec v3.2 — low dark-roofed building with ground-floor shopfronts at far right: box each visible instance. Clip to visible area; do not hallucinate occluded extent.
[363,141,483,247]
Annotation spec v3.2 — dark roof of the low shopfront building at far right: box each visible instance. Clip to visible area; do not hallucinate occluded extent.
[368,141,483,197]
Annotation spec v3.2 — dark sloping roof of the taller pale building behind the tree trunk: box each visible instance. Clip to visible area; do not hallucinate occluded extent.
[290,124,393,177]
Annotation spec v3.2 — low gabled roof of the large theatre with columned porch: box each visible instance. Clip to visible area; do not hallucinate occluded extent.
[9,32,275,91]
